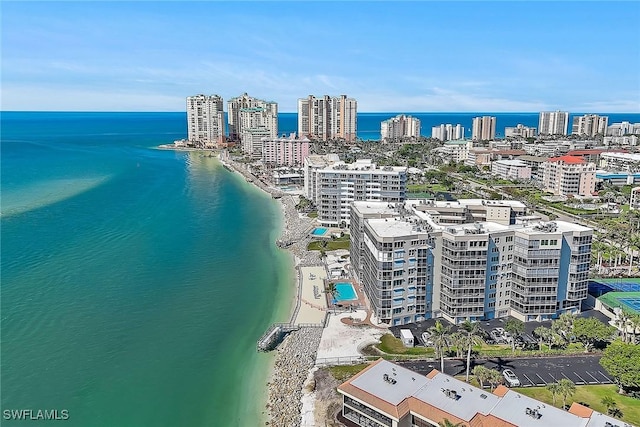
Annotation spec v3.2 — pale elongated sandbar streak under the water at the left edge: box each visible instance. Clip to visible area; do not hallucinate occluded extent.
[0,176,111,217]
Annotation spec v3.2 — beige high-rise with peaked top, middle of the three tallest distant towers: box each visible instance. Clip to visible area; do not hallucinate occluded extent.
[227,93,278,142]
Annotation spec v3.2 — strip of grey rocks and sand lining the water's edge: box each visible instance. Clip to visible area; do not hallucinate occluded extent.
[219,152,326,426]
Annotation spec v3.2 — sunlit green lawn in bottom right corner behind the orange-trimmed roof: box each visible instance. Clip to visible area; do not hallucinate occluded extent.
[514,384,640,425]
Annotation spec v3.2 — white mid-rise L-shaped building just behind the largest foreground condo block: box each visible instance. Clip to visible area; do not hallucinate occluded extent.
[304,155,407,227]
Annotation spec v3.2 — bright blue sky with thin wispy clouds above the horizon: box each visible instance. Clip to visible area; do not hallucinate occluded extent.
[0,1,640,112]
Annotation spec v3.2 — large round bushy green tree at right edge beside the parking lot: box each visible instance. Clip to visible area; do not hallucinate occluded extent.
[600,340,640,393]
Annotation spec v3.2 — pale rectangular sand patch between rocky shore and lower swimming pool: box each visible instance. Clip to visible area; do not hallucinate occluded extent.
[293,266,327,325]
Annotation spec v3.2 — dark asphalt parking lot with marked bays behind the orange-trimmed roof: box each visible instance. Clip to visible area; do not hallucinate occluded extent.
[400,355,613,387]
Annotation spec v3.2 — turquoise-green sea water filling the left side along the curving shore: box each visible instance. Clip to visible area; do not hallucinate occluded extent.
[0,113,293,427]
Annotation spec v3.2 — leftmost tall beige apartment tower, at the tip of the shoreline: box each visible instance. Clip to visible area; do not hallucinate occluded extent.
[187,95,224,148]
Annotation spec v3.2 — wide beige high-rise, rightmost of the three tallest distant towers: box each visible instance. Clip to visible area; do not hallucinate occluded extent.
[298,95,358,142]
